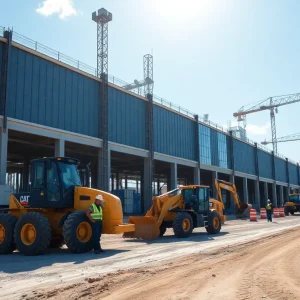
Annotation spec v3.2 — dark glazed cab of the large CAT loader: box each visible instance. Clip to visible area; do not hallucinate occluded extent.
[28,157,81,208]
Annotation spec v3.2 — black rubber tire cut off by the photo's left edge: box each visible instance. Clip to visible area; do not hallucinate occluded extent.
[0,213,17,254]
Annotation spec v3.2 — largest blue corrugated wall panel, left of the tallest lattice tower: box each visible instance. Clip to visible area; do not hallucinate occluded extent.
[8,47,100,137]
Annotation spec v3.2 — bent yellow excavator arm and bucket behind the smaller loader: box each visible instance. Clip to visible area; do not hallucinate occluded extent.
[215,179,252,217]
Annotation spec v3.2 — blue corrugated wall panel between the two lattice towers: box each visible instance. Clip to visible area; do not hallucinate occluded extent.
[108,88,147,149]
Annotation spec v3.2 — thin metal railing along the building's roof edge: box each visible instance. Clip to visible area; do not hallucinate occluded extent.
[0,26,298,161]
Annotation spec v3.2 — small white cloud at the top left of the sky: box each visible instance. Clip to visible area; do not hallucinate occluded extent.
[36,0,77,19]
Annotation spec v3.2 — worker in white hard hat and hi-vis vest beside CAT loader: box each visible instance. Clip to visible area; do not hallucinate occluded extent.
[86,195,104,254]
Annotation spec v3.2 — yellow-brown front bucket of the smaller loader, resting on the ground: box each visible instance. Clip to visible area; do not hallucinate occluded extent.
[123,217,160,240]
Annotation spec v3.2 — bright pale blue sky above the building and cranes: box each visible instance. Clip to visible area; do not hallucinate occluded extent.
[0,0,300,161]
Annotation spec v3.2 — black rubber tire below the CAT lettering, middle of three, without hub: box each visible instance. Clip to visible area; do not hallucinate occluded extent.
[15,212,51,256]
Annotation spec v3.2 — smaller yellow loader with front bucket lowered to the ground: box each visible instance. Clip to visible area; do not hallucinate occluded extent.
[123,185,226,240]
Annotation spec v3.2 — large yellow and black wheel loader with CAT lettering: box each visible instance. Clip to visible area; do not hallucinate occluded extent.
[0,157,135,255]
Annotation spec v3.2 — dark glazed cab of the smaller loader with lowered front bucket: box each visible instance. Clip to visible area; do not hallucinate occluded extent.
[182,186,210,213]
